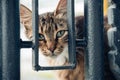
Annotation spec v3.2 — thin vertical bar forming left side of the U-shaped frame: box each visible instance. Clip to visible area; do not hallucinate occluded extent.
[32,0,39,70]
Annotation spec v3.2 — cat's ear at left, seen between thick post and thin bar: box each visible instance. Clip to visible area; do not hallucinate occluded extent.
[20,4,32,39]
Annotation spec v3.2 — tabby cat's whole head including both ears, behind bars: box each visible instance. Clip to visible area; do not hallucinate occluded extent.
[20,0,68,57]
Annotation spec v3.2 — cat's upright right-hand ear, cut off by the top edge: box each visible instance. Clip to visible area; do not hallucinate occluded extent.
[54,0,67,18]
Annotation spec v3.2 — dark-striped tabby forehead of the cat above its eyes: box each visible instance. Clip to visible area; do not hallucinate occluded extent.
[39,13,67,33]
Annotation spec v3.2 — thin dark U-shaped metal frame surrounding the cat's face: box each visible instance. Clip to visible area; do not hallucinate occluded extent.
[32,0,76,71]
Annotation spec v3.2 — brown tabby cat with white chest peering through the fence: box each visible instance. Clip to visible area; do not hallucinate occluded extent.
[20,0,113,80]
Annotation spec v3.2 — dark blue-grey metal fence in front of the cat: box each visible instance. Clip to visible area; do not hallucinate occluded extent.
[0,0,120,80]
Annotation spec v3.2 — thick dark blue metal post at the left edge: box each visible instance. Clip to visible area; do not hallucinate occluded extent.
[0,0,20,80]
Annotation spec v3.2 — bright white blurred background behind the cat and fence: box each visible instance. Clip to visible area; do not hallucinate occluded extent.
[20,0,84,80]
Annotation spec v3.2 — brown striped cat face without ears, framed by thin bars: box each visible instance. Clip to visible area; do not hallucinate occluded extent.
[39,13,68,57]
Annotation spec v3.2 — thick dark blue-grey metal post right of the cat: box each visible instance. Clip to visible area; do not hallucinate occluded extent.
[85,0,104,80]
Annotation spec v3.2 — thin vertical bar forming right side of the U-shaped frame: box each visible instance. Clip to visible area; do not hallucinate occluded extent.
[67,0,76,66]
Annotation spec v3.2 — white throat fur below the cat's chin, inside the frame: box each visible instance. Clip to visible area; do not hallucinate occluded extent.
[39,46,69,66]
